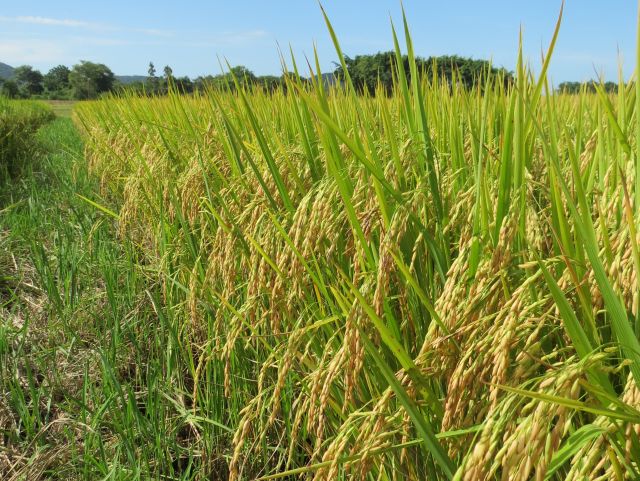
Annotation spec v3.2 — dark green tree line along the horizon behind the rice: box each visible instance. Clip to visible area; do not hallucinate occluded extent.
[0,52,617,100]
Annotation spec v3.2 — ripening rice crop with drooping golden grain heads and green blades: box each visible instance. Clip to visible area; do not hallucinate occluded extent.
[0,4,640,481]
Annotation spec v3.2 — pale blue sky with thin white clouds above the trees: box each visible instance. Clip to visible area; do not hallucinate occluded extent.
[0,0,637,83]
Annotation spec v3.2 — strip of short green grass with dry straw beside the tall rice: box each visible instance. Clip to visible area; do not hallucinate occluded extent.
[0,119,208,480]
